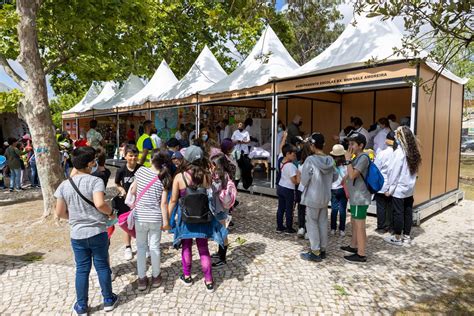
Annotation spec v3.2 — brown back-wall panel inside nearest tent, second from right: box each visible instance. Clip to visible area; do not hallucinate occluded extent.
[340,91,374,129]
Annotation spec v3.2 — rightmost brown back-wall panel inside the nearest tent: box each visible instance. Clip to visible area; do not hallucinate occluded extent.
[375,87,412,122]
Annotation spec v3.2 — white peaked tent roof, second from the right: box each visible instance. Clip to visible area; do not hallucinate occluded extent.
[202,26,299,94]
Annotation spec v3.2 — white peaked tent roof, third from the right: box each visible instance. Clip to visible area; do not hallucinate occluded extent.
[150,46,227,101]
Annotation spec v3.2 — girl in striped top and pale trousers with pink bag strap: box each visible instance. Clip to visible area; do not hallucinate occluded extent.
[130,150,171,291]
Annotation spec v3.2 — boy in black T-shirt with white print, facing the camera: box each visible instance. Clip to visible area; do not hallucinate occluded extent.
[115,145,141,260]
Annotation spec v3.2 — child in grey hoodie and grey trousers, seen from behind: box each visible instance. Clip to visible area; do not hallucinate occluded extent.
[300,133,337,262]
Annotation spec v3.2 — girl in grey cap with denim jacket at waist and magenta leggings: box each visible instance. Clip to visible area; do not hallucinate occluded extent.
[168,145,227,293]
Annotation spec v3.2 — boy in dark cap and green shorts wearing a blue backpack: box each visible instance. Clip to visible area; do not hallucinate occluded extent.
[341,132,372,263]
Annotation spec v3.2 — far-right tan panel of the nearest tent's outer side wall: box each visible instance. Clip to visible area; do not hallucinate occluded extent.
[446,82,463,192]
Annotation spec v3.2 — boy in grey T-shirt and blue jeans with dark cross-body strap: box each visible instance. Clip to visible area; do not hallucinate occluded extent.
[54,146,119,315]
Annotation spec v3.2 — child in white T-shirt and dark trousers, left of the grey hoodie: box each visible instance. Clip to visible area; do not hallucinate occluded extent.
[277,144,300,234]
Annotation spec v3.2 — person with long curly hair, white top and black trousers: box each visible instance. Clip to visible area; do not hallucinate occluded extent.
[385,126,421,246]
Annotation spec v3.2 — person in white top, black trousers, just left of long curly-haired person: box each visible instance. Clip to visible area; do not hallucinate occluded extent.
[374,132,397,234]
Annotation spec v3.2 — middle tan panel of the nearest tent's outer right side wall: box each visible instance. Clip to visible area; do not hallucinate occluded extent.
[431,77,451,198]
